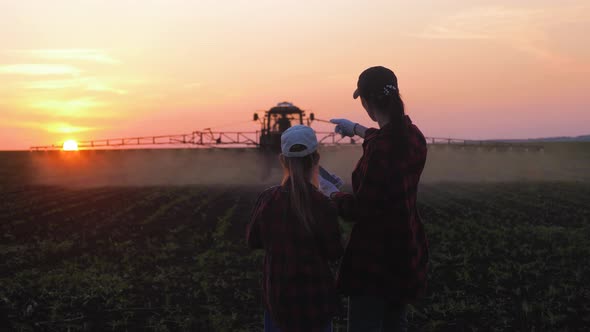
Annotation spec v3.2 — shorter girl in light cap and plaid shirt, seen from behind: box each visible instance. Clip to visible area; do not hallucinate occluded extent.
[247,125,343,332]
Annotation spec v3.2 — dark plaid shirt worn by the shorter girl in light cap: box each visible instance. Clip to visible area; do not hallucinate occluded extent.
[247,181,344,332]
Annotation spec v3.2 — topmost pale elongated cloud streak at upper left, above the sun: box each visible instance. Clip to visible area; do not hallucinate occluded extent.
[9,49,119,64]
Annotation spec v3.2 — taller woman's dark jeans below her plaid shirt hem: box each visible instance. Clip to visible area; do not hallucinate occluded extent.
[348,295,408,332]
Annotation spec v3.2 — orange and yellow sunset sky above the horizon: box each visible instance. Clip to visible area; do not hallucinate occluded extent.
[0,0,590,150]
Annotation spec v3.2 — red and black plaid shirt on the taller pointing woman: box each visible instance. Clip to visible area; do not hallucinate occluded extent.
[332,116,428,303]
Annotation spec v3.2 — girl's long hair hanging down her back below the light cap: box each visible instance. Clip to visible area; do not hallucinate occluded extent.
[283,144,319,232]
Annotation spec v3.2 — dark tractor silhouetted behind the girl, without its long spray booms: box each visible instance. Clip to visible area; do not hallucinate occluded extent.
[254,102,314,152]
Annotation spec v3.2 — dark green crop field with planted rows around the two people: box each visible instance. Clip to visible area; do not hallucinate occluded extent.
[0,147,590,331]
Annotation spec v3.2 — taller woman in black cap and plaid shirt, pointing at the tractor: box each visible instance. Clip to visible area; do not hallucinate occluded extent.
[322,67,428,331]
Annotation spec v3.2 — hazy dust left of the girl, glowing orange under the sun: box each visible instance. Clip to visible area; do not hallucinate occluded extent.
[31,149,280,187]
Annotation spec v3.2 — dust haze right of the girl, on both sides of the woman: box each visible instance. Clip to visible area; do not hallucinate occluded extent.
[322,143,590,183]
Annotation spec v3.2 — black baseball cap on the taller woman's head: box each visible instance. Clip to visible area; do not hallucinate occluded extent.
[352,66,398,99]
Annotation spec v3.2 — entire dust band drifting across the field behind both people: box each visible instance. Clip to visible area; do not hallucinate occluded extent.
[17,143,590,187]
